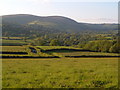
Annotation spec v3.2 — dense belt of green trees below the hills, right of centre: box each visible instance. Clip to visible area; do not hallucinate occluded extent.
[31,33,120,53]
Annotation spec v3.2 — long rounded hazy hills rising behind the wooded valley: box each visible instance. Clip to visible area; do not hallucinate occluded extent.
[2,14,118,36]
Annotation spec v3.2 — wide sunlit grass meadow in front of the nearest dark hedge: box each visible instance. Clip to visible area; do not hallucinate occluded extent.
[2,58,118,88]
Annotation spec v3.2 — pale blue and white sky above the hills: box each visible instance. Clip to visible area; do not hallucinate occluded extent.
[0,0,118,23]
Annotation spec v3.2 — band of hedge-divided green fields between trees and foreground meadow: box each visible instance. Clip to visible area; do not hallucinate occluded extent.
[0,45,118,57]
